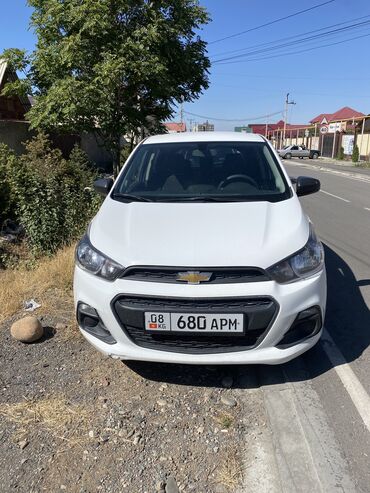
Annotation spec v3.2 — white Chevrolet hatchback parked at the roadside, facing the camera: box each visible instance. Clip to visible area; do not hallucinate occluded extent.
[74,132,326,364]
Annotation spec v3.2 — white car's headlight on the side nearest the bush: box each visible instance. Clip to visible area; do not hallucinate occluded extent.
[76,235,123,281]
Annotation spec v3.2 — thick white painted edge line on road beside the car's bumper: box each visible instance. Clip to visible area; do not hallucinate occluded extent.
[322,329,370,431]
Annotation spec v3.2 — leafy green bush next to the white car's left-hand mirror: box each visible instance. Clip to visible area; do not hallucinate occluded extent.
[6,134,101,254]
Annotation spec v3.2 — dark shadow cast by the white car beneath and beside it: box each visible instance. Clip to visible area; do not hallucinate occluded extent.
[124,245,370,389]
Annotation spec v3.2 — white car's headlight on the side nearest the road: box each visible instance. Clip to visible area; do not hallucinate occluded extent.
[267,224,324,284]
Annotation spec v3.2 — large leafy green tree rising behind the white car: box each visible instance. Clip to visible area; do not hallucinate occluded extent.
[3,0,210,173]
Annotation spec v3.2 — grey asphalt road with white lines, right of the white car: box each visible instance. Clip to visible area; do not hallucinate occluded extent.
[231,159,370,493]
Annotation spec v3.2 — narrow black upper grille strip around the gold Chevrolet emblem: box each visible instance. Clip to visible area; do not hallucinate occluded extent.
[121,266,269,284]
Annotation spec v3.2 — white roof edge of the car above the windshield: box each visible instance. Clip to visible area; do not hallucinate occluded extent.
[143,132,265,144]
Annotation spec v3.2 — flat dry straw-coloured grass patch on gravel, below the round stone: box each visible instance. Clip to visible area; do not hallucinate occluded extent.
[0,395,92,445]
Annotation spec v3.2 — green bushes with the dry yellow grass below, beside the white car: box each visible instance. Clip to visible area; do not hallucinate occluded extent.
[0,134,97,326]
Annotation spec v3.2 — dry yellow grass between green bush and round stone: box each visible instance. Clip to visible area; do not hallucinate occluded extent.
[0,246,74,324]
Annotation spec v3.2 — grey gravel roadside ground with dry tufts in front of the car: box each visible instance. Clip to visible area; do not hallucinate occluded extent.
[0,311,263,493]
